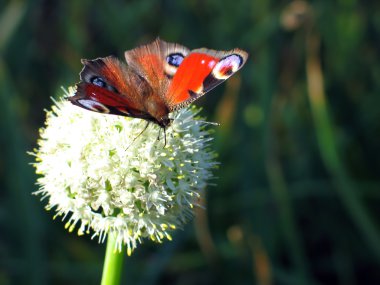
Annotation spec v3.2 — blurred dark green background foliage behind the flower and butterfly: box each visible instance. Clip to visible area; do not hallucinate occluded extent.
[0,0,380,285]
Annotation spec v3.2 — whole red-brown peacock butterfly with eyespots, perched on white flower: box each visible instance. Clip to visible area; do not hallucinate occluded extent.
[68,38,248,129]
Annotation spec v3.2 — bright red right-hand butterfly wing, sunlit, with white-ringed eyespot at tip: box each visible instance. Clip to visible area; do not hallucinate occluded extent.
[164,48,248,111]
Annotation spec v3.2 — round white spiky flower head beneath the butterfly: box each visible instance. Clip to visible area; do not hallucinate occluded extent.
[33,88,217,254]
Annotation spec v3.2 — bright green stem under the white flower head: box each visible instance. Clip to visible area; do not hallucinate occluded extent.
[101,234,124,285]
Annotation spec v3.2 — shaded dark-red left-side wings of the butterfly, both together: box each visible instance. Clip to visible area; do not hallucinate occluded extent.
[68,56,152,120]
